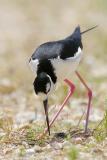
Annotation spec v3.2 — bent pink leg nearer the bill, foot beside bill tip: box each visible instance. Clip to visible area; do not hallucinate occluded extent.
[44,79,75,134]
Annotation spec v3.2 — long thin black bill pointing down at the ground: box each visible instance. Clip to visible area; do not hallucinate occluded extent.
[43,99,50,135]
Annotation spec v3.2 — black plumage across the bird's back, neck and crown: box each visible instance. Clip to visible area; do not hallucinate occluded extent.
[31,26,83,93]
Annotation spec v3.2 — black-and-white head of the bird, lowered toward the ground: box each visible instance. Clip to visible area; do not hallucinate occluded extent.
[33,72,52,100]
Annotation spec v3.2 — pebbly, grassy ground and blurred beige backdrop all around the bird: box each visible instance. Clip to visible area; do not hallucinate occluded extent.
[0,0,107,160]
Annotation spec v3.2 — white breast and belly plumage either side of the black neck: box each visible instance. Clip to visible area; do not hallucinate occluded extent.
[29,47,82,81]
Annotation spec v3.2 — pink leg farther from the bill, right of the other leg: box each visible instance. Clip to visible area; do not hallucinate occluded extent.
[75,71,92,133]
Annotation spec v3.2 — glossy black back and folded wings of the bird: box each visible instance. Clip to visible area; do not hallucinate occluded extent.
[32,26,83,60]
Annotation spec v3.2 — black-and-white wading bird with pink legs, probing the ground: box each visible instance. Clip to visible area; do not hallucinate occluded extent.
[29,25,97,135]
